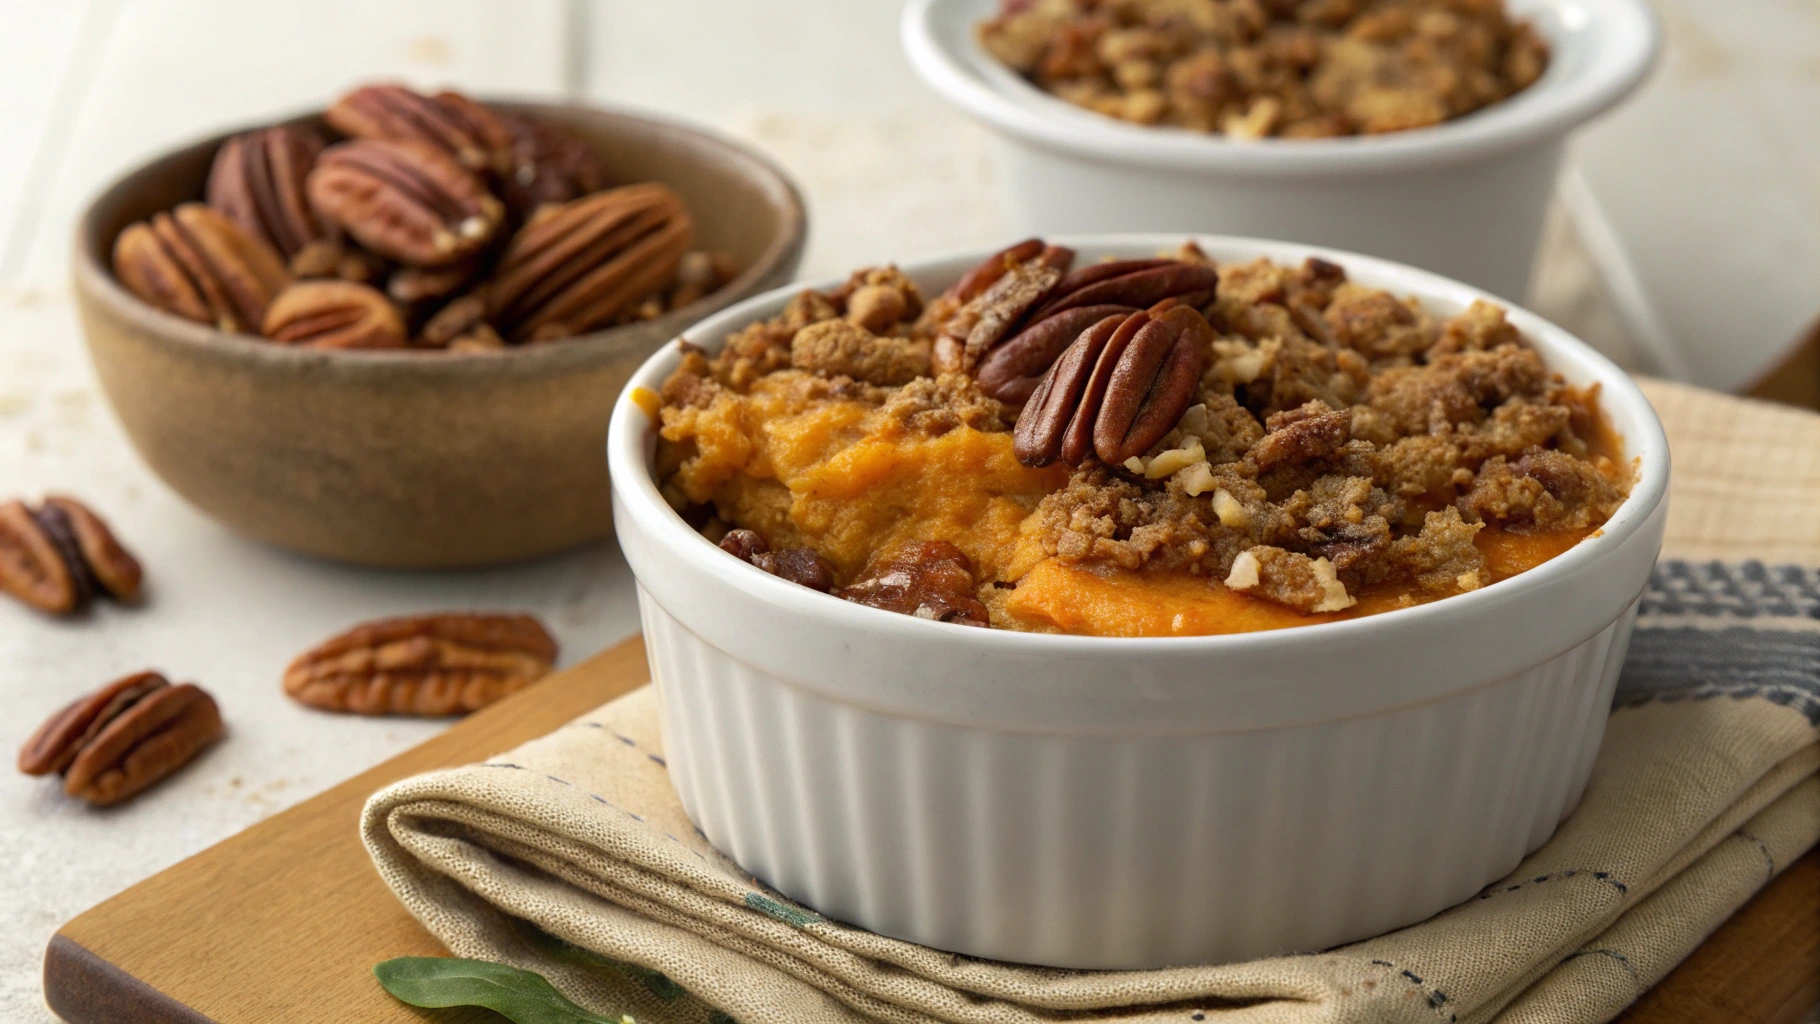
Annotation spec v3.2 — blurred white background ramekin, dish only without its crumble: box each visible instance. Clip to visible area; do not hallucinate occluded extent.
[903,0,1660,300]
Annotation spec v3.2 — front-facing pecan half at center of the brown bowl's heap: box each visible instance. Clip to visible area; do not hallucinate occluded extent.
[308,138,506,267]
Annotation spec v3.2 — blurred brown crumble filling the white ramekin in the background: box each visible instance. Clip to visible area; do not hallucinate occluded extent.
[976,0,1549,138]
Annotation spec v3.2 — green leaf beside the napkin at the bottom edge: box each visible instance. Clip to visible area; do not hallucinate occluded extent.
[373,957,635,1024]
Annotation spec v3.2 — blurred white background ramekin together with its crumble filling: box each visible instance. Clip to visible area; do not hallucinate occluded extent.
[903,0,1660,300]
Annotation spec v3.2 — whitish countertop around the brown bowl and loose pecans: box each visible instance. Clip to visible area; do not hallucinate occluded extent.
[0,0,1805,1020]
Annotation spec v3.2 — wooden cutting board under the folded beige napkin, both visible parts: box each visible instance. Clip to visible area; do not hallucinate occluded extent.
[44,638,1820,1024]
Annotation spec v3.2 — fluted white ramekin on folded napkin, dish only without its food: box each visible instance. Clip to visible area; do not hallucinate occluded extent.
[608,235,1669,968]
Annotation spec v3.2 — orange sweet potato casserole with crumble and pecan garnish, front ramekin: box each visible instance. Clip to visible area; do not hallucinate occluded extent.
[648,240,1631,637]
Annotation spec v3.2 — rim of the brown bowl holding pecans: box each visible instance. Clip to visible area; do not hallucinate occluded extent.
[69,95,808,373]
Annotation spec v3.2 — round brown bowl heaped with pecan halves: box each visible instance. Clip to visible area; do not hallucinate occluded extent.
[73,85,806,567]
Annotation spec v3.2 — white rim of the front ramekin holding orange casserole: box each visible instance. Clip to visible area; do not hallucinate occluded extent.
[606,233,1669,658]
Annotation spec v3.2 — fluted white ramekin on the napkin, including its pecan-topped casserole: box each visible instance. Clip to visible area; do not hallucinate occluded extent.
[608,235,1669,969]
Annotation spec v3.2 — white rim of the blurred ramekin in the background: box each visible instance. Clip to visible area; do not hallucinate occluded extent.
[899,0,1662,178]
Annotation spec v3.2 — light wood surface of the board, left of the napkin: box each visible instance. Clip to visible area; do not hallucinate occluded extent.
[46,637,650,1024]
